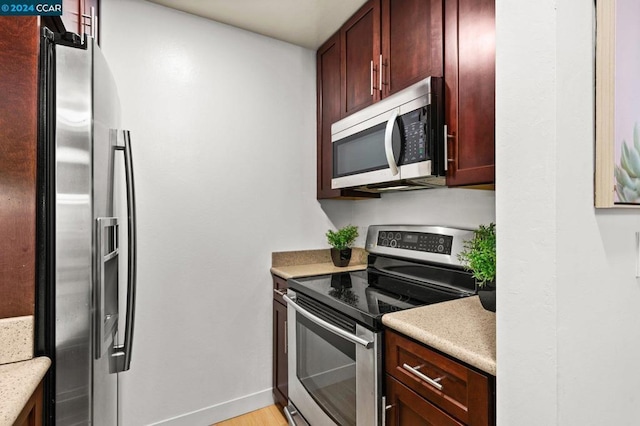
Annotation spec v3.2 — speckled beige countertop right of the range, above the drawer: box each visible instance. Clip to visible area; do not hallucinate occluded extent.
[382,296,496,376]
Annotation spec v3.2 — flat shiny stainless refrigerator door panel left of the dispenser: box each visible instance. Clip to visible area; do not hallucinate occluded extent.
[52,38,93,425]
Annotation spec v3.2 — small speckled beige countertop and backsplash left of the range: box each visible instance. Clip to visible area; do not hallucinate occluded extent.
[271,247,367,279]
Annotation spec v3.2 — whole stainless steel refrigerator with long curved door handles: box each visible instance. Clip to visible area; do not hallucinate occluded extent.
[36,28,136,426]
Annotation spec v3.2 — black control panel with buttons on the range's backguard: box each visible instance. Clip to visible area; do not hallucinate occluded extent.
[378,230,453,255]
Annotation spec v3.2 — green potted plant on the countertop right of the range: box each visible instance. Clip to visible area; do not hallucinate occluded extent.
[458,223,496,312]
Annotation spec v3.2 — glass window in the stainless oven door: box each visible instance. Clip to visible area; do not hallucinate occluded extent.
[296,314,356,426]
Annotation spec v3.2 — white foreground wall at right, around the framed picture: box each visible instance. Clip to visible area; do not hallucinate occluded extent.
[496,0,640,426]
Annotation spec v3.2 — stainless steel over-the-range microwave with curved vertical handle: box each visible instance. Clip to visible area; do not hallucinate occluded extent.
[331,77,447,192]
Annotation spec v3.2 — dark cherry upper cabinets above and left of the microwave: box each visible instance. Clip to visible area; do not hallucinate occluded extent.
[317,0,443,199]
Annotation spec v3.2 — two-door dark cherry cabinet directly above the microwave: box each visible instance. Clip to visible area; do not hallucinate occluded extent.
[340,0,443,111]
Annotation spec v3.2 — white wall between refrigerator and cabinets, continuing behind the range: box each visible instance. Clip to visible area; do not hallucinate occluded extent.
[101,0,494,426]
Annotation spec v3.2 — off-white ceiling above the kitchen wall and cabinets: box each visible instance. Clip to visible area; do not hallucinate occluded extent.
[143,0,366,50]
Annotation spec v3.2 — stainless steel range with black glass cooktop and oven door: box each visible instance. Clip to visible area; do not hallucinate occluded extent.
[284,225,476,426]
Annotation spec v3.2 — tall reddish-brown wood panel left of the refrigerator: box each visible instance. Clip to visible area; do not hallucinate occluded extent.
[0,16,39,318]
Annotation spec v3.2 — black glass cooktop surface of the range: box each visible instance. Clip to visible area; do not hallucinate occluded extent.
[288,269,470,329]
